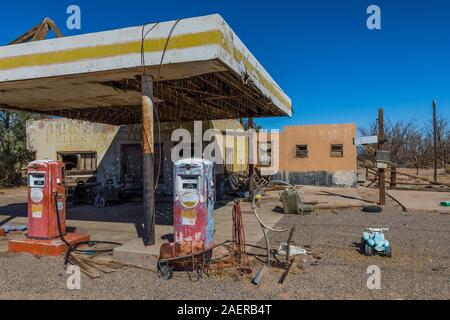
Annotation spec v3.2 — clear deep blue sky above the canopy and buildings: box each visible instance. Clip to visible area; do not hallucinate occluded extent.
[0,0,450,128]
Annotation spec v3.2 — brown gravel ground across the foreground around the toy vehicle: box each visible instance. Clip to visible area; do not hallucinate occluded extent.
[0,208,450,300]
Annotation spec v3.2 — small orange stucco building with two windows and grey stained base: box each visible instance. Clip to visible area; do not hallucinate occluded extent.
[268,124,357,186]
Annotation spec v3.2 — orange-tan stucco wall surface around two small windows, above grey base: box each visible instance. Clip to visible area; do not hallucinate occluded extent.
[280,124,357,172]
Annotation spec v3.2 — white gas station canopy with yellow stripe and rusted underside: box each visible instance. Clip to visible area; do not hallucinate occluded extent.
[0,15,292,125]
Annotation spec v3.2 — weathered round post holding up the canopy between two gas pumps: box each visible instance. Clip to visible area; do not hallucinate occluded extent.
[141,75,156,246]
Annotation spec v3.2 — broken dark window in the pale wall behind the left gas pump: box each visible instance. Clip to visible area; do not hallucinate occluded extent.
[58,152,97,175]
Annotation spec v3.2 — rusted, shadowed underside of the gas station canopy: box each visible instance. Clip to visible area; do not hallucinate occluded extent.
[0,67,283,125]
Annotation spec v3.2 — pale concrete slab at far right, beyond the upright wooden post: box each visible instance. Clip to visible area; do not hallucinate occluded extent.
[387,190,450,213]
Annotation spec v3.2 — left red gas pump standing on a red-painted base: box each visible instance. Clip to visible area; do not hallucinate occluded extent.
[8,160,90,256]
